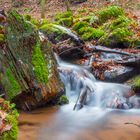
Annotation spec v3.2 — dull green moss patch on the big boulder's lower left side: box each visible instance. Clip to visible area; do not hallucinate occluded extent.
[2,69,21,100]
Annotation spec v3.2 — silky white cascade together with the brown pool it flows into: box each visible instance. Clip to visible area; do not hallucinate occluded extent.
[18,54,140,140]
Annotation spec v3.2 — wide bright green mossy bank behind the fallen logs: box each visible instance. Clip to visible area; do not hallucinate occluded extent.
[21,6,140,47]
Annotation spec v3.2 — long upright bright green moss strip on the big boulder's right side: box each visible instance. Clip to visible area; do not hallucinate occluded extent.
[32,43,48,84]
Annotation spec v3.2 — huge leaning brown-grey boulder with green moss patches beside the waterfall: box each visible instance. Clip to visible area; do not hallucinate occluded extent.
[0,10,64,110]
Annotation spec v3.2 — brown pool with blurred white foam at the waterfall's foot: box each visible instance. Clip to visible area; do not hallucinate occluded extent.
[18,105,140,140]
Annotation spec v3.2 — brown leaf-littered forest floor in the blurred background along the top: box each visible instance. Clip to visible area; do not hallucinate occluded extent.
[0,0,140,21]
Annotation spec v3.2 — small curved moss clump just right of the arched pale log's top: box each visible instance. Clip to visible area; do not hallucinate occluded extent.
[73,21,89,34]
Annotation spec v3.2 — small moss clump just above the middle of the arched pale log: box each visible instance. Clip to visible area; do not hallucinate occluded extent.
[58,17,73,27]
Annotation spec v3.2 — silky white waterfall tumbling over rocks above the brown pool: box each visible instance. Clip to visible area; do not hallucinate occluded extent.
[56,56,139,109]
